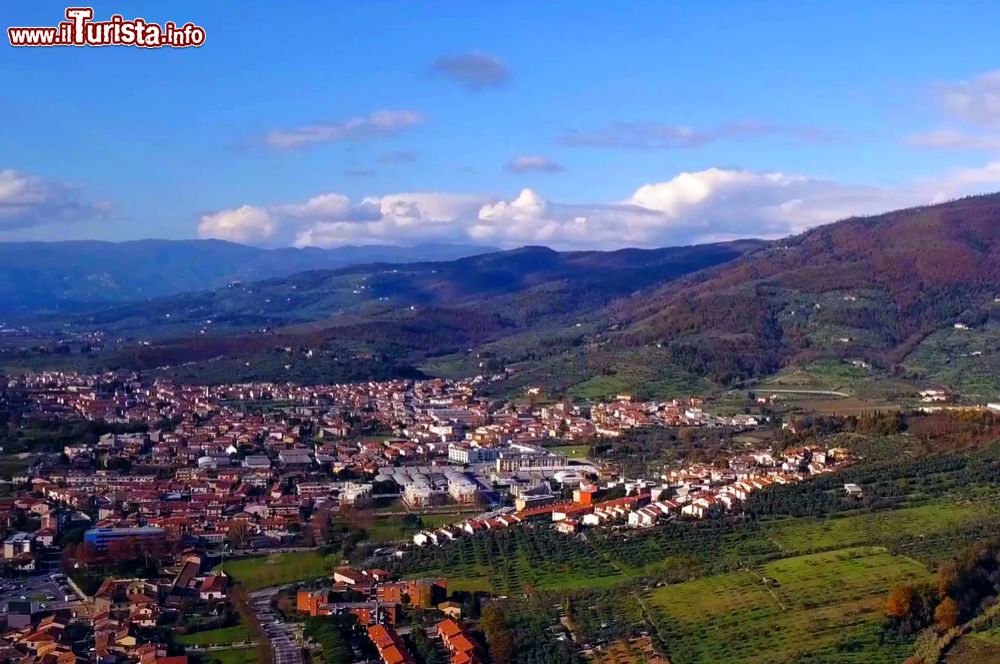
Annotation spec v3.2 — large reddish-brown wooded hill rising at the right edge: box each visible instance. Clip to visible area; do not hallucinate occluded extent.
[616,195,1000,383]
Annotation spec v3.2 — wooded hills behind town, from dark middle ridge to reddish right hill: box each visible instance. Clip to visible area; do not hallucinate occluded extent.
[5,195,1000,398]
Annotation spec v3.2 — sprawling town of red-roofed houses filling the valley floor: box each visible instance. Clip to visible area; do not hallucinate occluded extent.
[0,372,851,664]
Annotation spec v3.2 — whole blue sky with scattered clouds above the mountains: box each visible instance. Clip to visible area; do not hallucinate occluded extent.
[0,0,1000,248]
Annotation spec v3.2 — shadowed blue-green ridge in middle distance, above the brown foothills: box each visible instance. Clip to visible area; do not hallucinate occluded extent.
[80,240,764,333]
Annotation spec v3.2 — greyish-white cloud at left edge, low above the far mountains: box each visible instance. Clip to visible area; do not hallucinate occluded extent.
[0,168,109,231]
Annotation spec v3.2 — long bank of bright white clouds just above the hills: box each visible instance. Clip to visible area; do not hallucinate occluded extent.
[195,162,1000,249]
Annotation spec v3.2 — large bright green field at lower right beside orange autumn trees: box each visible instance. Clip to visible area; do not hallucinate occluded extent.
[645,547,931,664]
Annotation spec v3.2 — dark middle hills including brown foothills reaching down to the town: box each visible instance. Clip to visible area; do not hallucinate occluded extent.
[21,240,765,382]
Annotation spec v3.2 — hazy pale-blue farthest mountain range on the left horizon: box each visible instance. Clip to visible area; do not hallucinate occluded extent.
[0,240,495,314]
